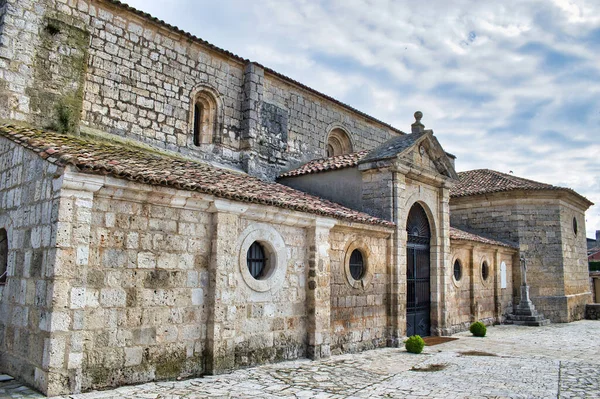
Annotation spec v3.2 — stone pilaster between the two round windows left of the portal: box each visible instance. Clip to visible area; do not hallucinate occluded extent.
[306,219,335,359]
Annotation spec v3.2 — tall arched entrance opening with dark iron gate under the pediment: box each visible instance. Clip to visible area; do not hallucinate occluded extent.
[406,204,431,337]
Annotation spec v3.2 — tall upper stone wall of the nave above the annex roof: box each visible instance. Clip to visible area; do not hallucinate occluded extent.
[0,0,400,180]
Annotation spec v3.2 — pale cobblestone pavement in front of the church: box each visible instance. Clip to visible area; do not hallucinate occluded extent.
[0,320,600,399]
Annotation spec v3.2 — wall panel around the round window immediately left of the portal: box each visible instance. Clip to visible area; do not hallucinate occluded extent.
[330,230,391,353]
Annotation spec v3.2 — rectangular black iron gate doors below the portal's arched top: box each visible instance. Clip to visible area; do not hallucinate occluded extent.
[406,243,431,337]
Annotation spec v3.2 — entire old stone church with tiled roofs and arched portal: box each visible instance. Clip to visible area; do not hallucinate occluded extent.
[0,0,592,396]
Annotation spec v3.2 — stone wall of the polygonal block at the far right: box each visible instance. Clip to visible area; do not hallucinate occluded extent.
[450,192,589,322]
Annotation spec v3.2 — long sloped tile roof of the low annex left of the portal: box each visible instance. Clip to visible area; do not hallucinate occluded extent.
[0,126,394,226]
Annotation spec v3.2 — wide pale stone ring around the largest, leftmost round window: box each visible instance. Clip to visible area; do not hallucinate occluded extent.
[238,223,287,292]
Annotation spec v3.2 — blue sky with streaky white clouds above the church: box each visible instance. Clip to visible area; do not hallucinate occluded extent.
[127,0,600,237]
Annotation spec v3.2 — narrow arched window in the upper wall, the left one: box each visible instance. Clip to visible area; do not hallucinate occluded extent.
[191,90,217,147]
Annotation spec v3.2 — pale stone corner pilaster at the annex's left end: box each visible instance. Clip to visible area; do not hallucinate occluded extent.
[46,172,103,396]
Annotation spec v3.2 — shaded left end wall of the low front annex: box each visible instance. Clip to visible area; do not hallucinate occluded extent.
[0,138,64,392]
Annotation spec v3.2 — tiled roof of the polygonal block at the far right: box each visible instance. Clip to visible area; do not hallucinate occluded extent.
[450,169,592,205]
